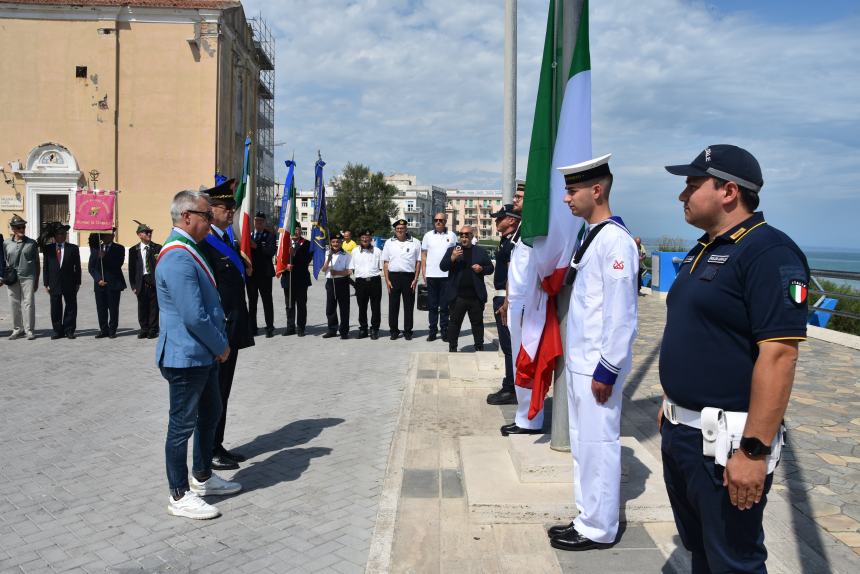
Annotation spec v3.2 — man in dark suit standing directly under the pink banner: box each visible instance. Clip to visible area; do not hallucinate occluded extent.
[87,228,126,339]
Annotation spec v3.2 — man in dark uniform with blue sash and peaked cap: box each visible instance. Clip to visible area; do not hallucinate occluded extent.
[200,180,254,470]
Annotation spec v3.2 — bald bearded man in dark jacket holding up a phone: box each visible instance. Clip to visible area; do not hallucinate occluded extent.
[439,225,493,353]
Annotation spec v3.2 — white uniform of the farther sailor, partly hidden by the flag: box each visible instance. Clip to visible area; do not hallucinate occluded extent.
[508,236,543,429]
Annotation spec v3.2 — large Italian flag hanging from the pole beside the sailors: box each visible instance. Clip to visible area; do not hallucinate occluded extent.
[516,0,591,419]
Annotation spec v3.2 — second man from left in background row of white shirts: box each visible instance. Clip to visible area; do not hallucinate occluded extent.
[349,229,382,339]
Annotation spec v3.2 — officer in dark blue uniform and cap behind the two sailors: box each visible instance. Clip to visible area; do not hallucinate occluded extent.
[487,203,522,405]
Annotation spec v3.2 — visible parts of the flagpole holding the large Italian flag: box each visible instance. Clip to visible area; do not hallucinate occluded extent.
[549,0,584,452]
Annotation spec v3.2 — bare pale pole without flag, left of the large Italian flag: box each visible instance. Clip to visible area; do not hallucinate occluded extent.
[502,0,517,203]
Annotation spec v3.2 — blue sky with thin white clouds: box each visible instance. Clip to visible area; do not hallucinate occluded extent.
[244,0,860,247]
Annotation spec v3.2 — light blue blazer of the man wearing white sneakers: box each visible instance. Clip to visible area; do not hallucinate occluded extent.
[155,230,227,369]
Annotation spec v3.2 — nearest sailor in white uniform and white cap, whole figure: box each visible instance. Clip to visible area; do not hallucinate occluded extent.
[549,155,639,550]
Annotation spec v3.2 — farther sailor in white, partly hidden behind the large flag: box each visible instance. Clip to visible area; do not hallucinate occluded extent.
[499,180,543,436]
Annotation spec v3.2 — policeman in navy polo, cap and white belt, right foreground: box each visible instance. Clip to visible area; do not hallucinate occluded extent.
[658,145,809,573]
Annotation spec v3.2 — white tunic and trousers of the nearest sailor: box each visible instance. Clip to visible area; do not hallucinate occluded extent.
[565,221,639,543]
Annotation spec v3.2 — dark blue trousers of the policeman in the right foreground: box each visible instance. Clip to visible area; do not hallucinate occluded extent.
[661,422,773,574]
